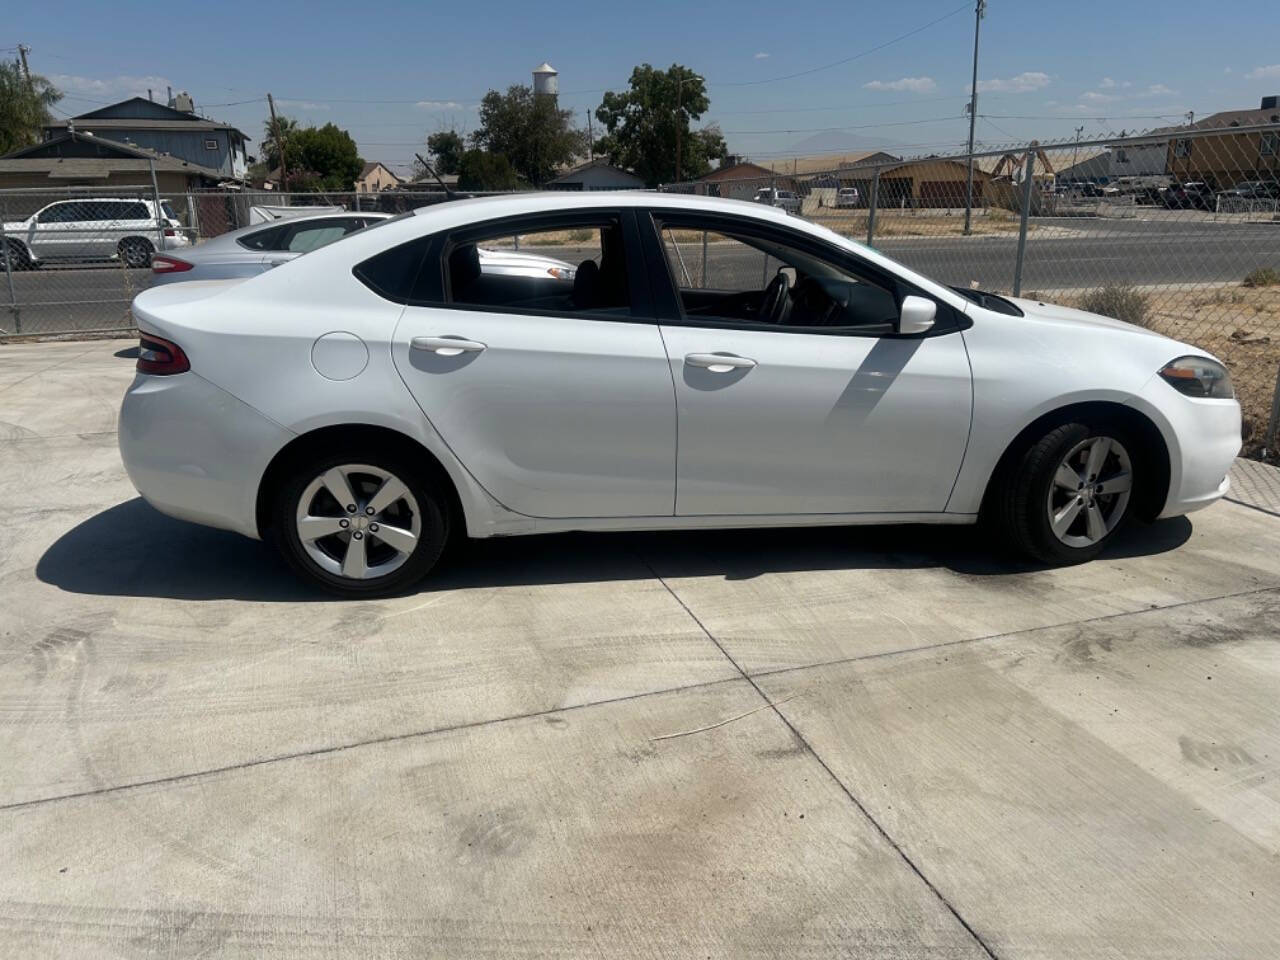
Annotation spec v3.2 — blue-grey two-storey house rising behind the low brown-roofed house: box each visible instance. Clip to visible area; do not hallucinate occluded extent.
[45,93,248,180]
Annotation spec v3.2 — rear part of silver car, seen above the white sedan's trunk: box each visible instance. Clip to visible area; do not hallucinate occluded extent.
[151,212,390,285]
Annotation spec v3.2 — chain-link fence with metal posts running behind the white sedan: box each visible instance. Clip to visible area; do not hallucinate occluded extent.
[0,122,1280,453]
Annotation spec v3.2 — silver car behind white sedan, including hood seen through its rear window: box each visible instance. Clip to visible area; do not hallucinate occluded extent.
[151,212,573,287]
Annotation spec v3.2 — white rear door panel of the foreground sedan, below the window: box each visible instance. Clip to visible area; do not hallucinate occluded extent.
[393,306,676,517]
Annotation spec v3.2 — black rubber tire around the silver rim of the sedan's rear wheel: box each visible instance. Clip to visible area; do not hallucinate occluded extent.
[269,451,452,598]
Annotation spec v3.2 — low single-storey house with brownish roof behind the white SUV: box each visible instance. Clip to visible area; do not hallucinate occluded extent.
[0,131,221,193]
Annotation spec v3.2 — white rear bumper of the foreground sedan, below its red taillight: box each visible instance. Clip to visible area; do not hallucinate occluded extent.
[119,371,293,539]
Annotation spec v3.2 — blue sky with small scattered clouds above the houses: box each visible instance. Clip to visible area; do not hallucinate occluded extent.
[10,0,1280,173]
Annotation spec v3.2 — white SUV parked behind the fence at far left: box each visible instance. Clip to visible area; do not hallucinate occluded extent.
[0,197,189,270]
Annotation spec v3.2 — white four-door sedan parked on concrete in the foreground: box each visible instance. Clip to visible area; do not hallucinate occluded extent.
[119,193,1240,596]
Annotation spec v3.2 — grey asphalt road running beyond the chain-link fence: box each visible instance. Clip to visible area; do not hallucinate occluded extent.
[0,218,1280,333]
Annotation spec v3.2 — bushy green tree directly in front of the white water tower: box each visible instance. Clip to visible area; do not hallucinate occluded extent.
[471,83,586,187]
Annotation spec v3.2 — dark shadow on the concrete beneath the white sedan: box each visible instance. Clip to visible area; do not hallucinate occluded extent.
[36,498,1192,603]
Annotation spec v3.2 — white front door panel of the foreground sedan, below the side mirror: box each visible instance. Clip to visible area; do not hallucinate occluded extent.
[662,325,973,516]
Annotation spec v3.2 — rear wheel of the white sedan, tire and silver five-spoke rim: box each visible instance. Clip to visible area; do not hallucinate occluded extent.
[271,452,449,596]
